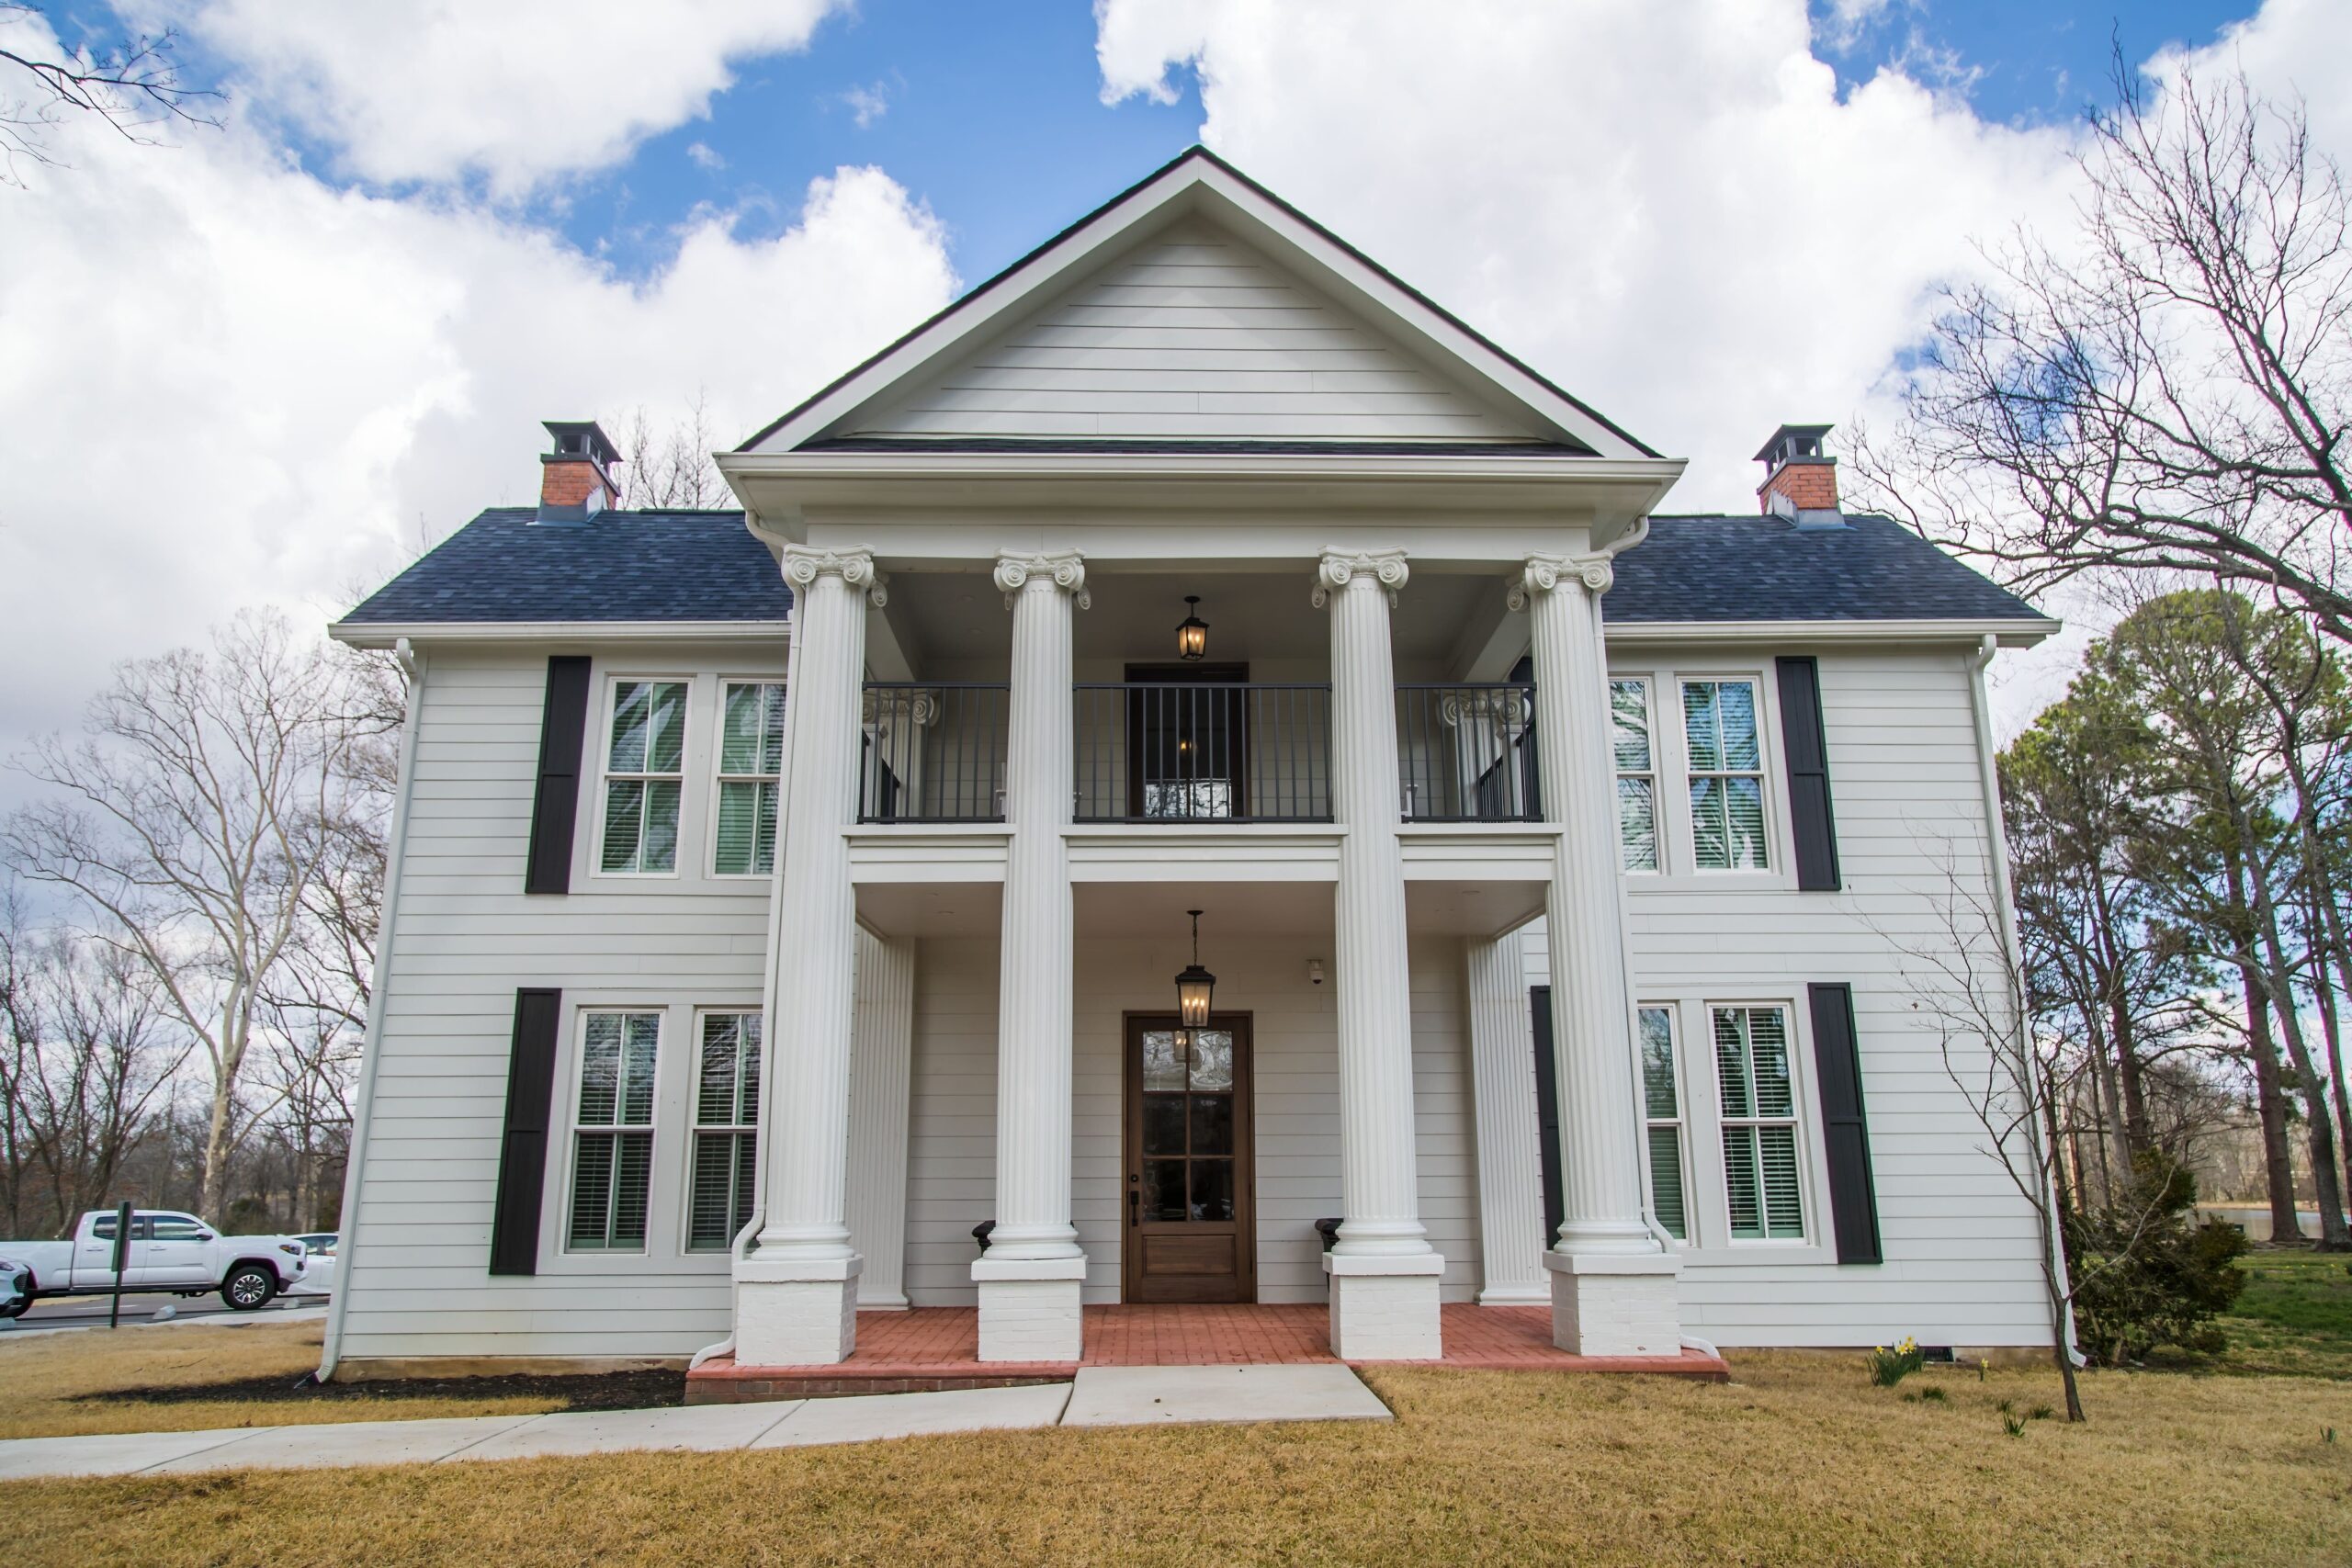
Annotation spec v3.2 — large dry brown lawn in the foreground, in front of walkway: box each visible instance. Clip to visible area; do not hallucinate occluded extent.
[0,1357,2352,1568]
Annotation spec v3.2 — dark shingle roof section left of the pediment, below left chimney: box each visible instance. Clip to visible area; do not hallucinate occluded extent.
[344,505,793,626]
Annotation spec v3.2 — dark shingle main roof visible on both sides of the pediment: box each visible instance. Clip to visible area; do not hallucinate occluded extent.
[345,508,2041,626]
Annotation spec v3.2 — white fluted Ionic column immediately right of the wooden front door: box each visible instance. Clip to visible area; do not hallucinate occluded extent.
[1315,550,1444,1359]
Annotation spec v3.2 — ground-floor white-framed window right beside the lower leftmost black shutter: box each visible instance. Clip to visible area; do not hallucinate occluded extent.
[564,1010,661,1253]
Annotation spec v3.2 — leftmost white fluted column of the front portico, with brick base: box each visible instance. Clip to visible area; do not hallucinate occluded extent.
[736,546,882,1366]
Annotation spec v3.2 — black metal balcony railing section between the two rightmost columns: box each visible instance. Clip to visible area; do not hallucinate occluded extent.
[1397,682,1543,823]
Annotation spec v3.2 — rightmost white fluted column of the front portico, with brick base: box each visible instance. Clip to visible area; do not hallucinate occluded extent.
[1510,555,1681,1357]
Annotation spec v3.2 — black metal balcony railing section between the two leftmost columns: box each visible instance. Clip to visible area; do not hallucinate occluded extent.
[858,682,1012,823]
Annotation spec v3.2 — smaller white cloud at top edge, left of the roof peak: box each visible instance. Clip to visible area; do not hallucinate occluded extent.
[151,0,842,197]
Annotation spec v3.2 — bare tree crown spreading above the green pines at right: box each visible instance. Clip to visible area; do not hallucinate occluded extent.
[1851,59,2352,639]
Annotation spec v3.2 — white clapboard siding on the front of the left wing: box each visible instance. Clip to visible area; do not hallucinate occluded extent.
[344,644,783,1359]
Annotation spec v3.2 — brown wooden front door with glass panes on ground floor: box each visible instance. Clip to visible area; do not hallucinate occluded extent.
[1120,1013,1259,1303]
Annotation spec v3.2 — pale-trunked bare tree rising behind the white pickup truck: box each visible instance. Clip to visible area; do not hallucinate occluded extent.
[0,614,367,1213]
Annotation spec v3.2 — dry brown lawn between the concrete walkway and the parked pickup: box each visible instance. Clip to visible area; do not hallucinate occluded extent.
[0,1321,564,1438]
